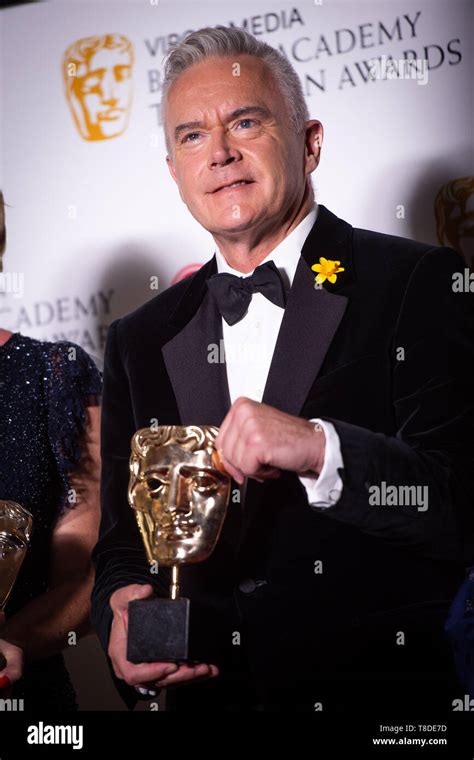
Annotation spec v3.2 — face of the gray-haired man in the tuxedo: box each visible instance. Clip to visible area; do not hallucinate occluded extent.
[166,55,317,236]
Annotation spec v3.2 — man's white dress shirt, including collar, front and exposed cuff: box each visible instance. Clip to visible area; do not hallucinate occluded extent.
[215,204,343,509]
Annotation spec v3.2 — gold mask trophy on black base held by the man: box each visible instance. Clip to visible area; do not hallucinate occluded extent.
[127,425,231,663]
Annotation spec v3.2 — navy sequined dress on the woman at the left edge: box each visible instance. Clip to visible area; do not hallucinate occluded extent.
[0,333,101,710]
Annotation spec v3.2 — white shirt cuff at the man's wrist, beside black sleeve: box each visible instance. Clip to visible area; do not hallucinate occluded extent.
[298,418,344,509]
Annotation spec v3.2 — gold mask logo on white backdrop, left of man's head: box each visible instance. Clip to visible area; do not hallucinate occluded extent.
[62,34,134,140]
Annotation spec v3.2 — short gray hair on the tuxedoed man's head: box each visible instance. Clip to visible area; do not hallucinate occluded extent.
[161,26,309,153]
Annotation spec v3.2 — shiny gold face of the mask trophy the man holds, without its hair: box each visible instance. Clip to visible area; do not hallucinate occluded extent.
[130,441,230,565]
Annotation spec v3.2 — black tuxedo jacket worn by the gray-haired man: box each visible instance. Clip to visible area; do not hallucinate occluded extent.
[92,206,474,712]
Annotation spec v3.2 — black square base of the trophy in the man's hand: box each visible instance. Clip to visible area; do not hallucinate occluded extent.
[127,597,190,663]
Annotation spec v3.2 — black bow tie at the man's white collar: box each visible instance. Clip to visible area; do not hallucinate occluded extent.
[206,261,286,325]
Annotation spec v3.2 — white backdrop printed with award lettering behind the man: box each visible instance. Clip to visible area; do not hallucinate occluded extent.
[0,0,474,359]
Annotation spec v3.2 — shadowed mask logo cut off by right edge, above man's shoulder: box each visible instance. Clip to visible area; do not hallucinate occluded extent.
[435,177,474,271]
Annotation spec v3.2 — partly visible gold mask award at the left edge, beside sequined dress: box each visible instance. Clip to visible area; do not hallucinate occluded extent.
[0,501,33,611]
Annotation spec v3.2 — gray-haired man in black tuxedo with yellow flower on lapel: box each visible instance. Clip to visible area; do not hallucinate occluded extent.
[93,27,474,717]
